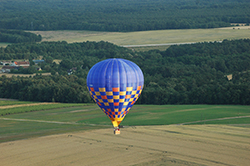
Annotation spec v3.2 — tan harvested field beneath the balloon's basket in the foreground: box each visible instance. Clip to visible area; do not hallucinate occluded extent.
[0,125,250,166]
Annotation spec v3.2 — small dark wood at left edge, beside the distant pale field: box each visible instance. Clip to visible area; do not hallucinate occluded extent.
[0,29,42,43]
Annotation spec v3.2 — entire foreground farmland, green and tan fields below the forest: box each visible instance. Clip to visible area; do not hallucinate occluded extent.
[0,101,250,166]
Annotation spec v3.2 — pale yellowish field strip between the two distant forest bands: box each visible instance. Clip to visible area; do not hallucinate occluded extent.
[29,26,250,45]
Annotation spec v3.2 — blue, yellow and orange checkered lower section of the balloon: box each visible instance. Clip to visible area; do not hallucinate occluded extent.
[88,86,143,119]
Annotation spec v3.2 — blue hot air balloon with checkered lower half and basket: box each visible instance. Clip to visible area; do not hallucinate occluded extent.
[87,58,144,134]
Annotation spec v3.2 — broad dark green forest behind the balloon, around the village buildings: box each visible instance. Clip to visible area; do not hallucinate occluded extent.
[0,39,250,105]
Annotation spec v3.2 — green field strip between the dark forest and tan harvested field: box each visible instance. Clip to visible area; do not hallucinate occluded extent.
[0,104,250,142]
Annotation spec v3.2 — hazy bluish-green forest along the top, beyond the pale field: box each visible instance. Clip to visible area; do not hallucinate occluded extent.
[0,0,250,31]
